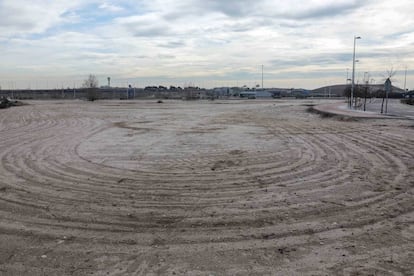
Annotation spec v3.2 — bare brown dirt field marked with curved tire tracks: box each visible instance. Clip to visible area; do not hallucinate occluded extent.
[0,100,414,275]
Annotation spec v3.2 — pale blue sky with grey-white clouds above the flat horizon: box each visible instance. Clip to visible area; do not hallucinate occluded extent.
[0,0,414,89]
